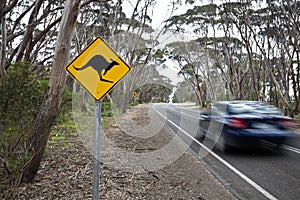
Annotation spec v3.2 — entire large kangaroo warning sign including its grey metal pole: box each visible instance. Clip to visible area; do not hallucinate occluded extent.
[66,37,131,200]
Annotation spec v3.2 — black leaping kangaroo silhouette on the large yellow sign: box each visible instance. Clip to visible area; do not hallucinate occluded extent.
[73,55,119,83]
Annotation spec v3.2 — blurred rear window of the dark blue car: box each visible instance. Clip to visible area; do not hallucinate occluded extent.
[228,102,282,115]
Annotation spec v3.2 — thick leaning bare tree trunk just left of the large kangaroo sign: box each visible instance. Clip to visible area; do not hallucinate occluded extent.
[22,0,80,182]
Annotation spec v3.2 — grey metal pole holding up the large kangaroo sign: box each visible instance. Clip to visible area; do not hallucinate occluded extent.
[92,101,102,200]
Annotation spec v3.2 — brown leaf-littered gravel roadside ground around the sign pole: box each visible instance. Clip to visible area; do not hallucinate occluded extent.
[5,105,236,200]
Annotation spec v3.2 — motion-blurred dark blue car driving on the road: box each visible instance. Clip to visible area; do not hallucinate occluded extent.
[198,101,294,152]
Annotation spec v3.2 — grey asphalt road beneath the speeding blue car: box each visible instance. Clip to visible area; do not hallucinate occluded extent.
[153,104,300,200]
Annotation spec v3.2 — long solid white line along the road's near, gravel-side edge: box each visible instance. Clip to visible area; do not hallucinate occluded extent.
[153,104,277,200]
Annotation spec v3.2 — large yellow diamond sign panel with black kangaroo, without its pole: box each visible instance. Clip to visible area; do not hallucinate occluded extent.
[66,37,131,101]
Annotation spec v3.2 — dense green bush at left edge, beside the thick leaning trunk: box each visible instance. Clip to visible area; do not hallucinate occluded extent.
[0,63,47,186]
